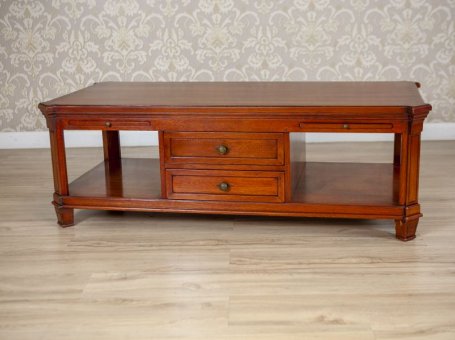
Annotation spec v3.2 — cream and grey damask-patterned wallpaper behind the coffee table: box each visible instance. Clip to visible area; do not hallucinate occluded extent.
[0,0,455,131]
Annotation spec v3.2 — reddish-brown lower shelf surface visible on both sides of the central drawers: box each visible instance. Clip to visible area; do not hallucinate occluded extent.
[69,158,399,208]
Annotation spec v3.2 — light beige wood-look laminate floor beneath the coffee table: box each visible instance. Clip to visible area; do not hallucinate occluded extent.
[0,141,455,340]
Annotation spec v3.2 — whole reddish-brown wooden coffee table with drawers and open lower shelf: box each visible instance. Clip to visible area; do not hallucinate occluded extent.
[39,82,431,241]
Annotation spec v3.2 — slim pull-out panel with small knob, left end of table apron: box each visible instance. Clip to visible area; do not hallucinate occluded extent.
[65,119,151,130]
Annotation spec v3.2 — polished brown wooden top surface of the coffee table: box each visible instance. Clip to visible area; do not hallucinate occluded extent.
[41,81,427,108]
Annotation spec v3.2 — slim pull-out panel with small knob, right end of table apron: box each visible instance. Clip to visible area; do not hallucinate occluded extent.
[299,122,393,132]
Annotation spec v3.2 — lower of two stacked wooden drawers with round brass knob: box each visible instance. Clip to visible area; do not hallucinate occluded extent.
[166,169,284,202]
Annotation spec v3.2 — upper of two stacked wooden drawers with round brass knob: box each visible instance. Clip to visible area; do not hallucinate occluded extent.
[164,132,284,165]
